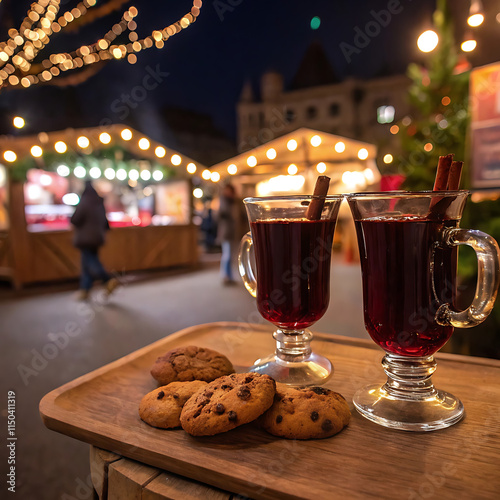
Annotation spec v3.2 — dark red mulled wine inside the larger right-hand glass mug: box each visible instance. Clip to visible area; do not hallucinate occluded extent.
[356,217,458,356]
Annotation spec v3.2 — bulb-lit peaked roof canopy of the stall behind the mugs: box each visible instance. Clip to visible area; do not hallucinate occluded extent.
[211,128,380,176]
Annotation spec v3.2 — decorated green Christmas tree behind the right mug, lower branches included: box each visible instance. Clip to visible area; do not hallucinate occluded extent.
[393,0,500,358]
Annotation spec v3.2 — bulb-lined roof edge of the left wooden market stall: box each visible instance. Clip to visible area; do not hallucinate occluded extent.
[0,124,206,177]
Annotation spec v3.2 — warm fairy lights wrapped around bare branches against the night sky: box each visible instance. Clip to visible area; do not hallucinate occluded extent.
[0,0,202,89]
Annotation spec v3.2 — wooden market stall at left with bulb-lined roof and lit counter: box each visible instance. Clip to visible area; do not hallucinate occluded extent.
[0,125,203,287]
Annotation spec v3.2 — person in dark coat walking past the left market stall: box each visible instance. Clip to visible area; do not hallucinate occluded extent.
[71,181,118,300]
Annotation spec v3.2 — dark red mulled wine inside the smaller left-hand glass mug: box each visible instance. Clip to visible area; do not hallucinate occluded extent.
[250,219,336,330]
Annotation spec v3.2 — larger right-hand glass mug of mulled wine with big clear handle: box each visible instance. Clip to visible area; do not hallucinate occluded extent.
[347,191,500,431]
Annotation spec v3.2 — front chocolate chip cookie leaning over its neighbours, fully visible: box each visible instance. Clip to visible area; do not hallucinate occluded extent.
[181,373,276,436]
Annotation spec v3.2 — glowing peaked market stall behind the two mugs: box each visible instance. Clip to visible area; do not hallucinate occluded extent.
[211,128,381,262]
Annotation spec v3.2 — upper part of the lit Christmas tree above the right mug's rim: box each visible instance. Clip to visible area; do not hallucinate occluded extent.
[394,0,469,190]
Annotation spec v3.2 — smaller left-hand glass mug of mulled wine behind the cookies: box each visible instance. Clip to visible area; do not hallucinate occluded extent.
[238,196,343,386]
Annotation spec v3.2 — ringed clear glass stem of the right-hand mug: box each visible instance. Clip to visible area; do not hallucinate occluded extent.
[382,354,437,400]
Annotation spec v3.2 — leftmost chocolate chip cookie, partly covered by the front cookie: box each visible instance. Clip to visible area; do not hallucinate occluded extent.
[139,380,207,429]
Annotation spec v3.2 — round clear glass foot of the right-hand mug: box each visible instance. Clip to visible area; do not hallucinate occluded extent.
[353,385,464,431]
